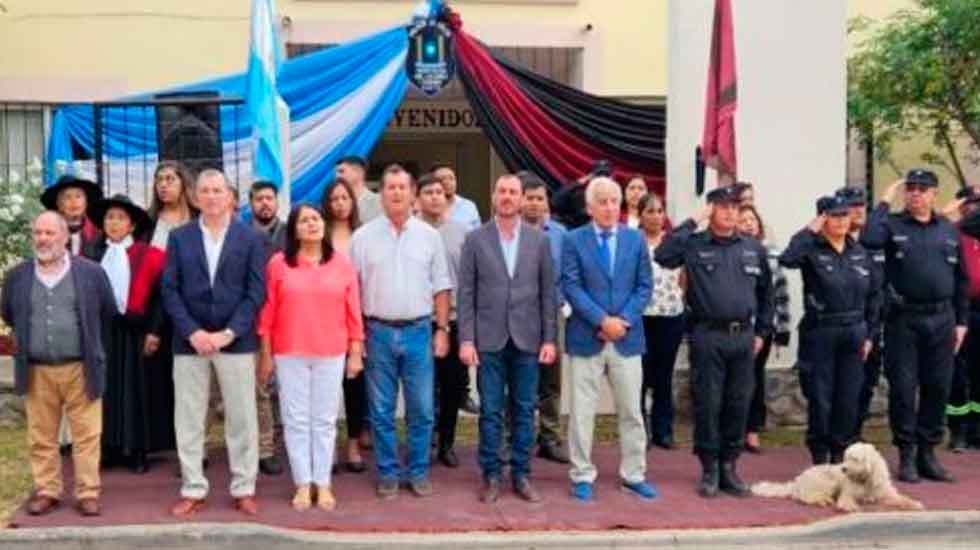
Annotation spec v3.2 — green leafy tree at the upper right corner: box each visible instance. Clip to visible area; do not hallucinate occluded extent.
[847,0,980,182]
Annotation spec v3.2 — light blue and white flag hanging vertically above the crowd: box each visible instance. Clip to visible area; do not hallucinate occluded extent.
[245,0,288,188]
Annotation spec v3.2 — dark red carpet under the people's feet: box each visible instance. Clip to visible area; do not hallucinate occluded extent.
[11,447,980,533]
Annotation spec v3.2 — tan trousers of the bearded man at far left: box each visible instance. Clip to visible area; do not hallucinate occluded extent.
[24,362,102,500]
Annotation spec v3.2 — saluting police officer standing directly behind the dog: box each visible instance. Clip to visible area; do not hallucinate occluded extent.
[779,195,881,464]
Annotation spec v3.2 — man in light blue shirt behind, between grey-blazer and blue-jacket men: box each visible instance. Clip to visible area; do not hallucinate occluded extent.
[517,172,571,464]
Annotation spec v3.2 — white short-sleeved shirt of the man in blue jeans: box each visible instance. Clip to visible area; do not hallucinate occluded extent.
[350,215,453,321]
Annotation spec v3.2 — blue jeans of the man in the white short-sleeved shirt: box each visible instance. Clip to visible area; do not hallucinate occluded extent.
[366,317,434,481]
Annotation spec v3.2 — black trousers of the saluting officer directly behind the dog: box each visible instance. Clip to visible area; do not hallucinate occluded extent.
[797,323,867,455]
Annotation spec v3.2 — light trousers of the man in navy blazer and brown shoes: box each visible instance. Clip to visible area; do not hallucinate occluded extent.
[174,353,259,499]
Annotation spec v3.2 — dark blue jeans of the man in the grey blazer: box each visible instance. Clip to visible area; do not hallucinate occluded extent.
[476,341,540,482]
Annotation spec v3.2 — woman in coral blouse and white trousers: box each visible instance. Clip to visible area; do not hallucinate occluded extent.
[258,204,364,510]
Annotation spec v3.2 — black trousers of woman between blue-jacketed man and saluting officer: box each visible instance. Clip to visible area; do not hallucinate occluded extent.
[640,315,687,440]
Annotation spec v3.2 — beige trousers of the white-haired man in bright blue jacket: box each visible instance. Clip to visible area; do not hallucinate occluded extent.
[568,343,647,483]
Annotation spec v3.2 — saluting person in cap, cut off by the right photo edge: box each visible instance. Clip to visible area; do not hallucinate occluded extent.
[944,187,980,453]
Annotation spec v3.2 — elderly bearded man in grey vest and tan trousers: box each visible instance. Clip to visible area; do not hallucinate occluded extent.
[2,211,116,516]
